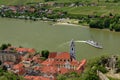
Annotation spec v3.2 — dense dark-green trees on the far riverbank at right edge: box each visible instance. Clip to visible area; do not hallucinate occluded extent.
[89,16,120,31]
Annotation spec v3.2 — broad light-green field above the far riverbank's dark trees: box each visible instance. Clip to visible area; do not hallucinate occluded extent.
[54,3,120,15]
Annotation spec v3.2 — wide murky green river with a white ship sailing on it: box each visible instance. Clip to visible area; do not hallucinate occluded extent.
[0,18,120,59]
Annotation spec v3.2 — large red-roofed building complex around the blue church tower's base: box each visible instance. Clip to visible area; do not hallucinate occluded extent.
[41,52,87,74]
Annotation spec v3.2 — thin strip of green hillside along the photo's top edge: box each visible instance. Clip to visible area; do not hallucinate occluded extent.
[0,0,119,5]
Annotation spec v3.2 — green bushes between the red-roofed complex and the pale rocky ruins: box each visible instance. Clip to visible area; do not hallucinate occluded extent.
[84,56,109,80]
